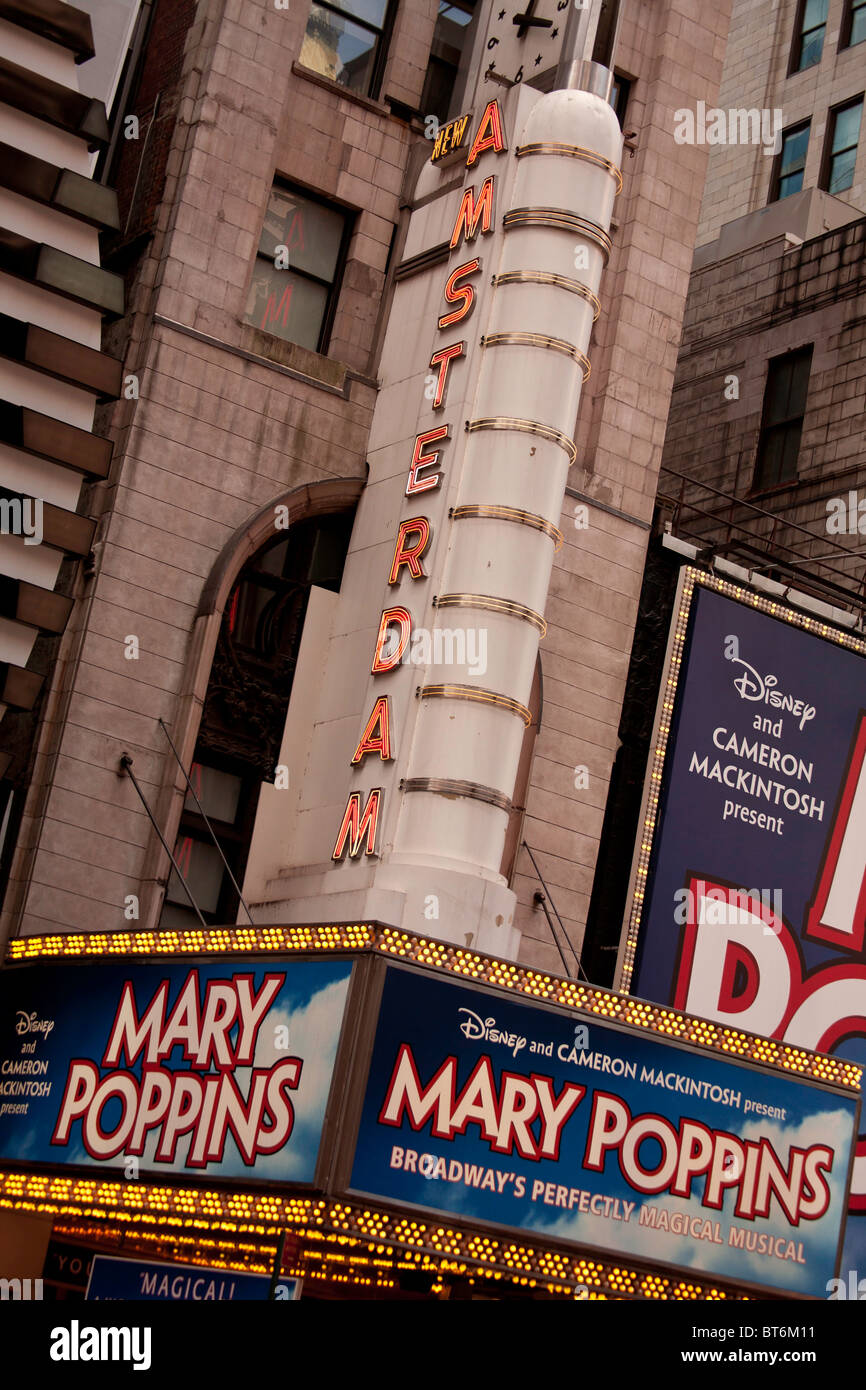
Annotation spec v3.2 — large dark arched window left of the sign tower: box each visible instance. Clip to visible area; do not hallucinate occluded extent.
[158,510,353,930]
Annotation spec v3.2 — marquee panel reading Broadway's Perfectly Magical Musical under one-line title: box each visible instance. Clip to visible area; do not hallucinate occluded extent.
[350,966,858,1297]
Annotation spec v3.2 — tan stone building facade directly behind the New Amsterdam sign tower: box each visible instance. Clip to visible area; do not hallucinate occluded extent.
[3,0,728,969]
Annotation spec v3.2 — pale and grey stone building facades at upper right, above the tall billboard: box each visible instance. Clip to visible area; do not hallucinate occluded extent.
[662,0,866,592]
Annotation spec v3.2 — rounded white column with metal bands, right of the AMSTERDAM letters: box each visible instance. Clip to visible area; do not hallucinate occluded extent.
[393,76,621,876]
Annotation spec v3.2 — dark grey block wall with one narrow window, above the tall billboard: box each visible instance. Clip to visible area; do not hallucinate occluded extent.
[662,220,866,591]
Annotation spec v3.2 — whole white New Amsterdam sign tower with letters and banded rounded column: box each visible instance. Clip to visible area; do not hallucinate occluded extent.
[256,2,623,956]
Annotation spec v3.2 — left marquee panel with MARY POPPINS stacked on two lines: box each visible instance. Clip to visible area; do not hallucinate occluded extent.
[0,959,352,1183]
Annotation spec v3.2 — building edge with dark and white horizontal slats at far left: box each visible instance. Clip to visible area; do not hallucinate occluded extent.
[0,0,124,934]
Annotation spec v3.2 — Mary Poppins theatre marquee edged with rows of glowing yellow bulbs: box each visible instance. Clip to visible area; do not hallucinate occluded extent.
[0,923,860,1300]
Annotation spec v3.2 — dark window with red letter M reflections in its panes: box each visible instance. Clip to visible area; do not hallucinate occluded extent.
[246,183,349,352]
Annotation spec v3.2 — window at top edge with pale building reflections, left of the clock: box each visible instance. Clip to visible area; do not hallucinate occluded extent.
[299,0,389,96]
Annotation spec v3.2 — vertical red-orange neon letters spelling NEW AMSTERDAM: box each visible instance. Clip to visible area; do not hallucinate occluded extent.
[332,100,506,860]
